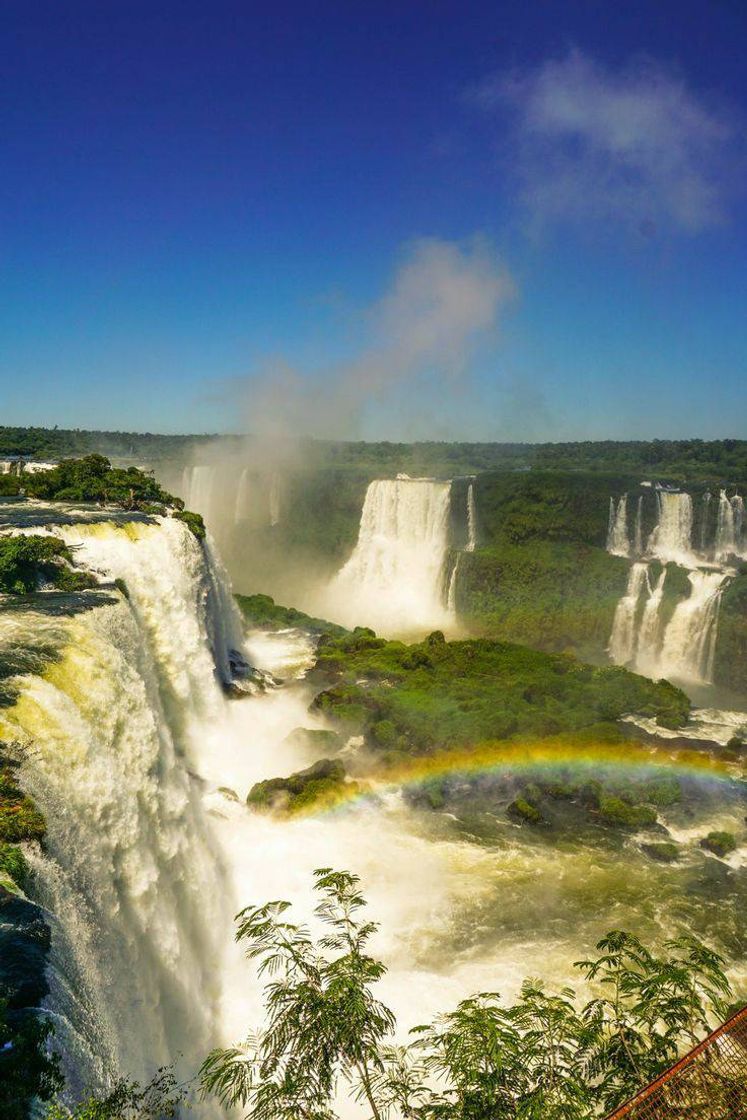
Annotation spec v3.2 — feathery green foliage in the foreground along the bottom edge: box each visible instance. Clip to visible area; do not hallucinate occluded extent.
[203,868,747,1120]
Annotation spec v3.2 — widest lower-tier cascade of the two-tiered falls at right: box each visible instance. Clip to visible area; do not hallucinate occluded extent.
[659,571,728,684]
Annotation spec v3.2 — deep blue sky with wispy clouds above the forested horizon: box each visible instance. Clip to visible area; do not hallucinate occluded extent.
[0,0,747,439]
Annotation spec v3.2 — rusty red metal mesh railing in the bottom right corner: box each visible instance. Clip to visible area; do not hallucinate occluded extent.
[607,1007,747,1120]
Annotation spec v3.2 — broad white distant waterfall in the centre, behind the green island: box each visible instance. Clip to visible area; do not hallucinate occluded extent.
[327,478,454,634]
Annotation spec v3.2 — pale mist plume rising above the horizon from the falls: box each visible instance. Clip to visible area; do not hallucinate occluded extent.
[242,239,514,441]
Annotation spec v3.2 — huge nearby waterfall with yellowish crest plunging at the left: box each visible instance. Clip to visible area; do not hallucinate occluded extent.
[0,520,239,1102]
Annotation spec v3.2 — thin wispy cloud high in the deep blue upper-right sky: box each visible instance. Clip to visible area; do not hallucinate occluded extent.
[477,50,740,234]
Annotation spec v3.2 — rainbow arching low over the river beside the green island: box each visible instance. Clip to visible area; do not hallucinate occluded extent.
[301,738,747,814]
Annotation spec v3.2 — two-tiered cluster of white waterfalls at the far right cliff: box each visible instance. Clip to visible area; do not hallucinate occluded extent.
[607,488,747,684]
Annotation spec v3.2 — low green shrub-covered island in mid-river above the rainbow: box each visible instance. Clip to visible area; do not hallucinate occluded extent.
[314,629,690,753]
